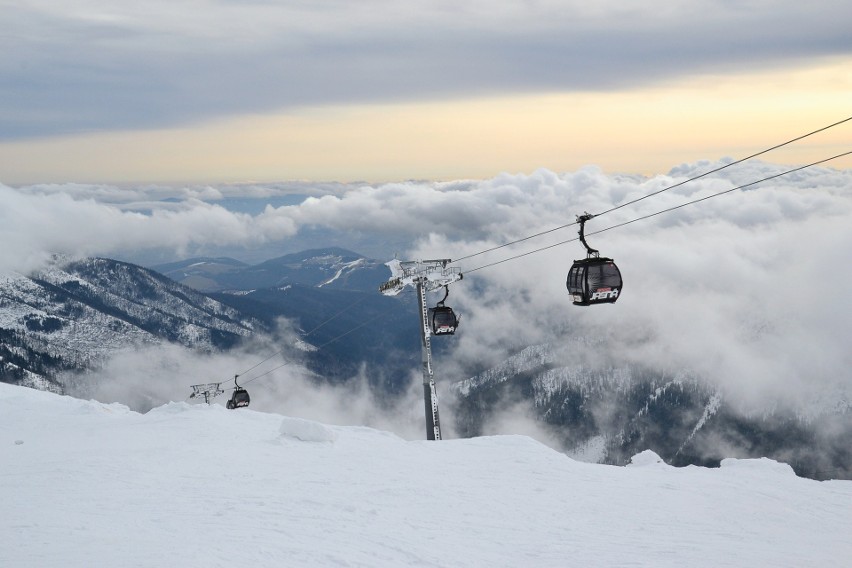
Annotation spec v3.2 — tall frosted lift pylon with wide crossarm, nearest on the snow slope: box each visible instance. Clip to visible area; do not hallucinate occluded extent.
[379,259,462,440]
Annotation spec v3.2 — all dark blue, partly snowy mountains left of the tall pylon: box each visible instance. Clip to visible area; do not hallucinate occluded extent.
[0,248,419,392]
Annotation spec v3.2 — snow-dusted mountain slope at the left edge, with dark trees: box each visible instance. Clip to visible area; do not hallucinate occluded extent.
[0,258,256,390]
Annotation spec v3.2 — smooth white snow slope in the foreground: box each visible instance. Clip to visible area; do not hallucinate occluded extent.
[0,384,852,568]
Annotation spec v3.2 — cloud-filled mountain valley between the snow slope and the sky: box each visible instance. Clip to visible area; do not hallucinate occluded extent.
[0,161,852,478]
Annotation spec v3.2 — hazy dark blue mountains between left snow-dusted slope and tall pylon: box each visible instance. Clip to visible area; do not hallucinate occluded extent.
[154,247,424,386]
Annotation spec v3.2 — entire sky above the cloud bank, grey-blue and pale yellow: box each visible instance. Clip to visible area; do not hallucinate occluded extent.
[0,0,852,185]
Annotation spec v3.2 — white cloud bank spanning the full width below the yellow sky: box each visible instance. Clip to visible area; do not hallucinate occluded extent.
[6,161,852,429]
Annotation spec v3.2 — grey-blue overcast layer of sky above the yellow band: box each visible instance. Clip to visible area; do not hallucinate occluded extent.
[0,0,852,141]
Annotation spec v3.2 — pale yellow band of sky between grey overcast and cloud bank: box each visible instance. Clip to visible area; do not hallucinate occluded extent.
[0,57,852,185]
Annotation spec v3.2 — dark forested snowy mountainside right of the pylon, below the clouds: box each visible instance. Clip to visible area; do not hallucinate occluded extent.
[452,339,852,479]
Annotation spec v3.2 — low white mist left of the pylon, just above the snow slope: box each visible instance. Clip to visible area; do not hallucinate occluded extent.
[64,328,432,439]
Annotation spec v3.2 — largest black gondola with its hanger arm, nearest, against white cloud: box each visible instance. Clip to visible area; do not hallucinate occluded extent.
[565,213,623,306]
